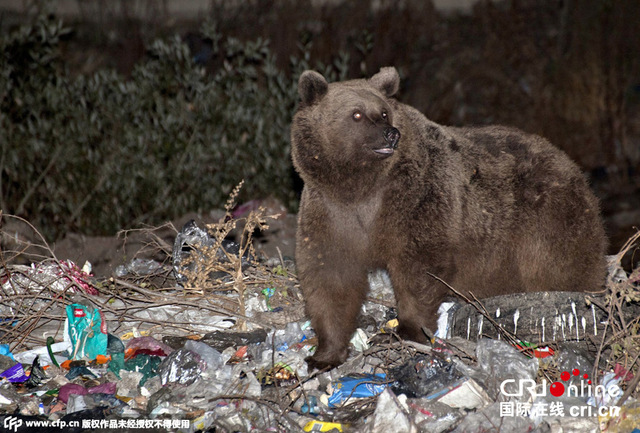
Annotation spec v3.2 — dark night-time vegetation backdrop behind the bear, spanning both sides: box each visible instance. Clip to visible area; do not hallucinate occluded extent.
[0,0,640,251]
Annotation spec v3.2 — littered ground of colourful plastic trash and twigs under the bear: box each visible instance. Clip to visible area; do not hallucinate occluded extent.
[0,211,640,433]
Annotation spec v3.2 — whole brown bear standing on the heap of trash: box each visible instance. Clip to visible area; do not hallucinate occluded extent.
[291,68,606,368]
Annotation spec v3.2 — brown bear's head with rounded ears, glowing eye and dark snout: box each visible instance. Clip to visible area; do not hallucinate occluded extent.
[291,68,400,192]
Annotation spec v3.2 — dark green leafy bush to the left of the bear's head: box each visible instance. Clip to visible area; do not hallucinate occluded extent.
[0,16,348,239]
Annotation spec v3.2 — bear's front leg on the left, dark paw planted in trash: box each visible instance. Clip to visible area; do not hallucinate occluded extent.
[298,260,368,369]
